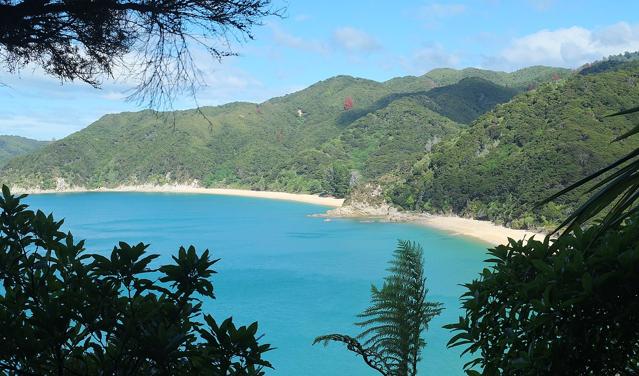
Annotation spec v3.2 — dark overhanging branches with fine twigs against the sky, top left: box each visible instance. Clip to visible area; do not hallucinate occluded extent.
[0,0,280,107]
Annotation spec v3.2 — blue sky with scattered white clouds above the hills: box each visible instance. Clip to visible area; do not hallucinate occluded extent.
[0,0,639,140]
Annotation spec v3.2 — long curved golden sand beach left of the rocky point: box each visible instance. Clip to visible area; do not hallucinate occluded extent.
[12,185,344,208]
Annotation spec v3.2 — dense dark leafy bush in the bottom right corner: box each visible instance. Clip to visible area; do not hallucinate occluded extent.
[447,217,639,375]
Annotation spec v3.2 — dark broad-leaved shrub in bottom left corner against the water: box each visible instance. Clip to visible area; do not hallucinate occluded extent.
[0,186,271,375]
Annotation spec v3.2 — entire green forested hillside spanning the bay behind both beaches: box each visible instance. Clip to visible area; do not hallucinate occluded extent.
[0,54,639,230]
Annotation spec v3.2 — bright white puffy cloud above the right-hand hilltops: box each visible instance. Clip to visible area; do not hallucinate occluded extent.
[496,22,639,69]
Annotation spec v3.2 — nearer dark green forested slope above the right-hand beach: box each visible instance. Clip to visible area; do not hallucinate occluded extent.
[389,60,639,227]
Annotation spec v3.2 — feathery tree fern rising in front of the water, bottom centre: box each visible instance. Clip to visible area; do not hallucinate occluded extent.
[313,241,443,376]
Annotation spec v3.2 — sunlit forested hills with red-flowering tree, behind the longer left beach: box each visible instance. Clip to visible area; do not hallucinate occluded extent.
[0,68,565,196]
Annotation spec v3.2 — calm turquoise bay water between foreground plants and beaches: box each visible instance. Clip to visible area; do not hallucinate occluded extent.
[22,193,486,376]
